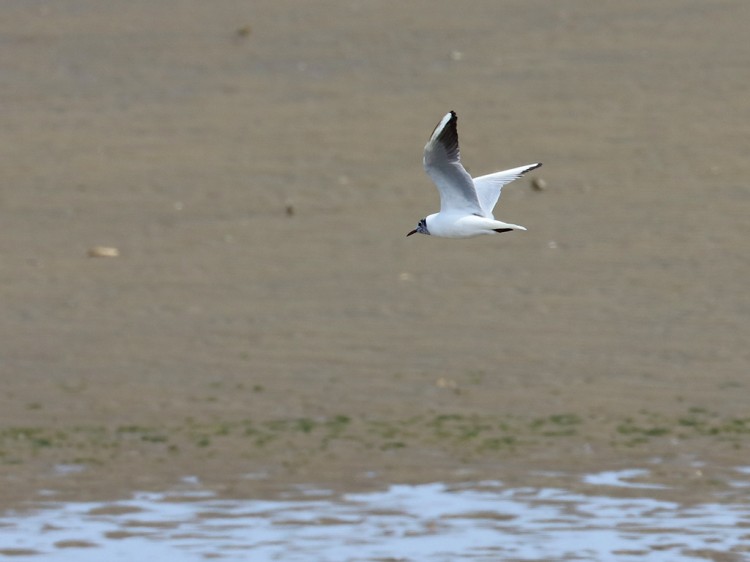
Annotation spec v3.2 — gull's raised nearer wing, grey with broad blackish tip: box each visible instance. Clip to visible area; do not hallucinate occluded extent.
[423,111,482,214]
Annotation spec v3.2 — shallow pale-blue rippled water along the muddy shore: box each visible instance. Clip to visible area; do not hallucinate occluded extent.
[0,468,750,562]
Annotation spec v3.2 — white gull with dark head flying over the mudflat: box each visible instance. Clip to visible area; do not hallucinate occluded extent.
[407,111,542,238]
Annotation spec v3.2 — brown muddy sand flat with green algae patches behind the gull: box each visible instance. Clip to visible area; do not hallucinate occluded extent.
[0,0,750,507]
